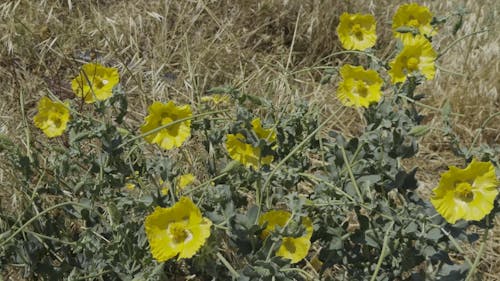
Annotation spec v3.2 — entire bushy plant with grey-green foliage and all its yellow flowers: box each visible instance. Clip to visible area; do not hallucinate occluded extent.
[0,4,500,280]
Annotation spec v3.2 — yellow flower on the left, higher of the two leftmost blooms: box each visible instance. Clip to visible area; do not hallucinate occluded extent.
[71,63,120,103]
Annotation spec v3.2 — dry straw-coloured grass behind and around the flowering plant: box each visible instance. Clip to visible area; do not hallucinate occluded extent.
[0,0,500,280]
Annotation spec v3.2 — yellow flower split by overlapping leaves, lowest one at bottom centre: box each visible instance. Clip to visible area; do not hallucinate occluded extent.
[259,210,313,263]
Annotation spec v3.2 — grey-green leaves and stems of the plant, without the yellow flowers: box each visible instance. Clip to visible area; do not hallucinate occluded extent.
[0,21,500,280]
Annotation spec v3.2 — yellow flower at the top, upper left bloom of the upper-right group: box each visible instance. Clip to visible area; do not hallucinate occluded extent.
[337,13,377,51]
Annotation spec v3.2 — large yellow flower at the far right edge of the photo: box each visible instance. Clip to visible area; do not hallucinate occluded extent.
[431,159,499,224]
